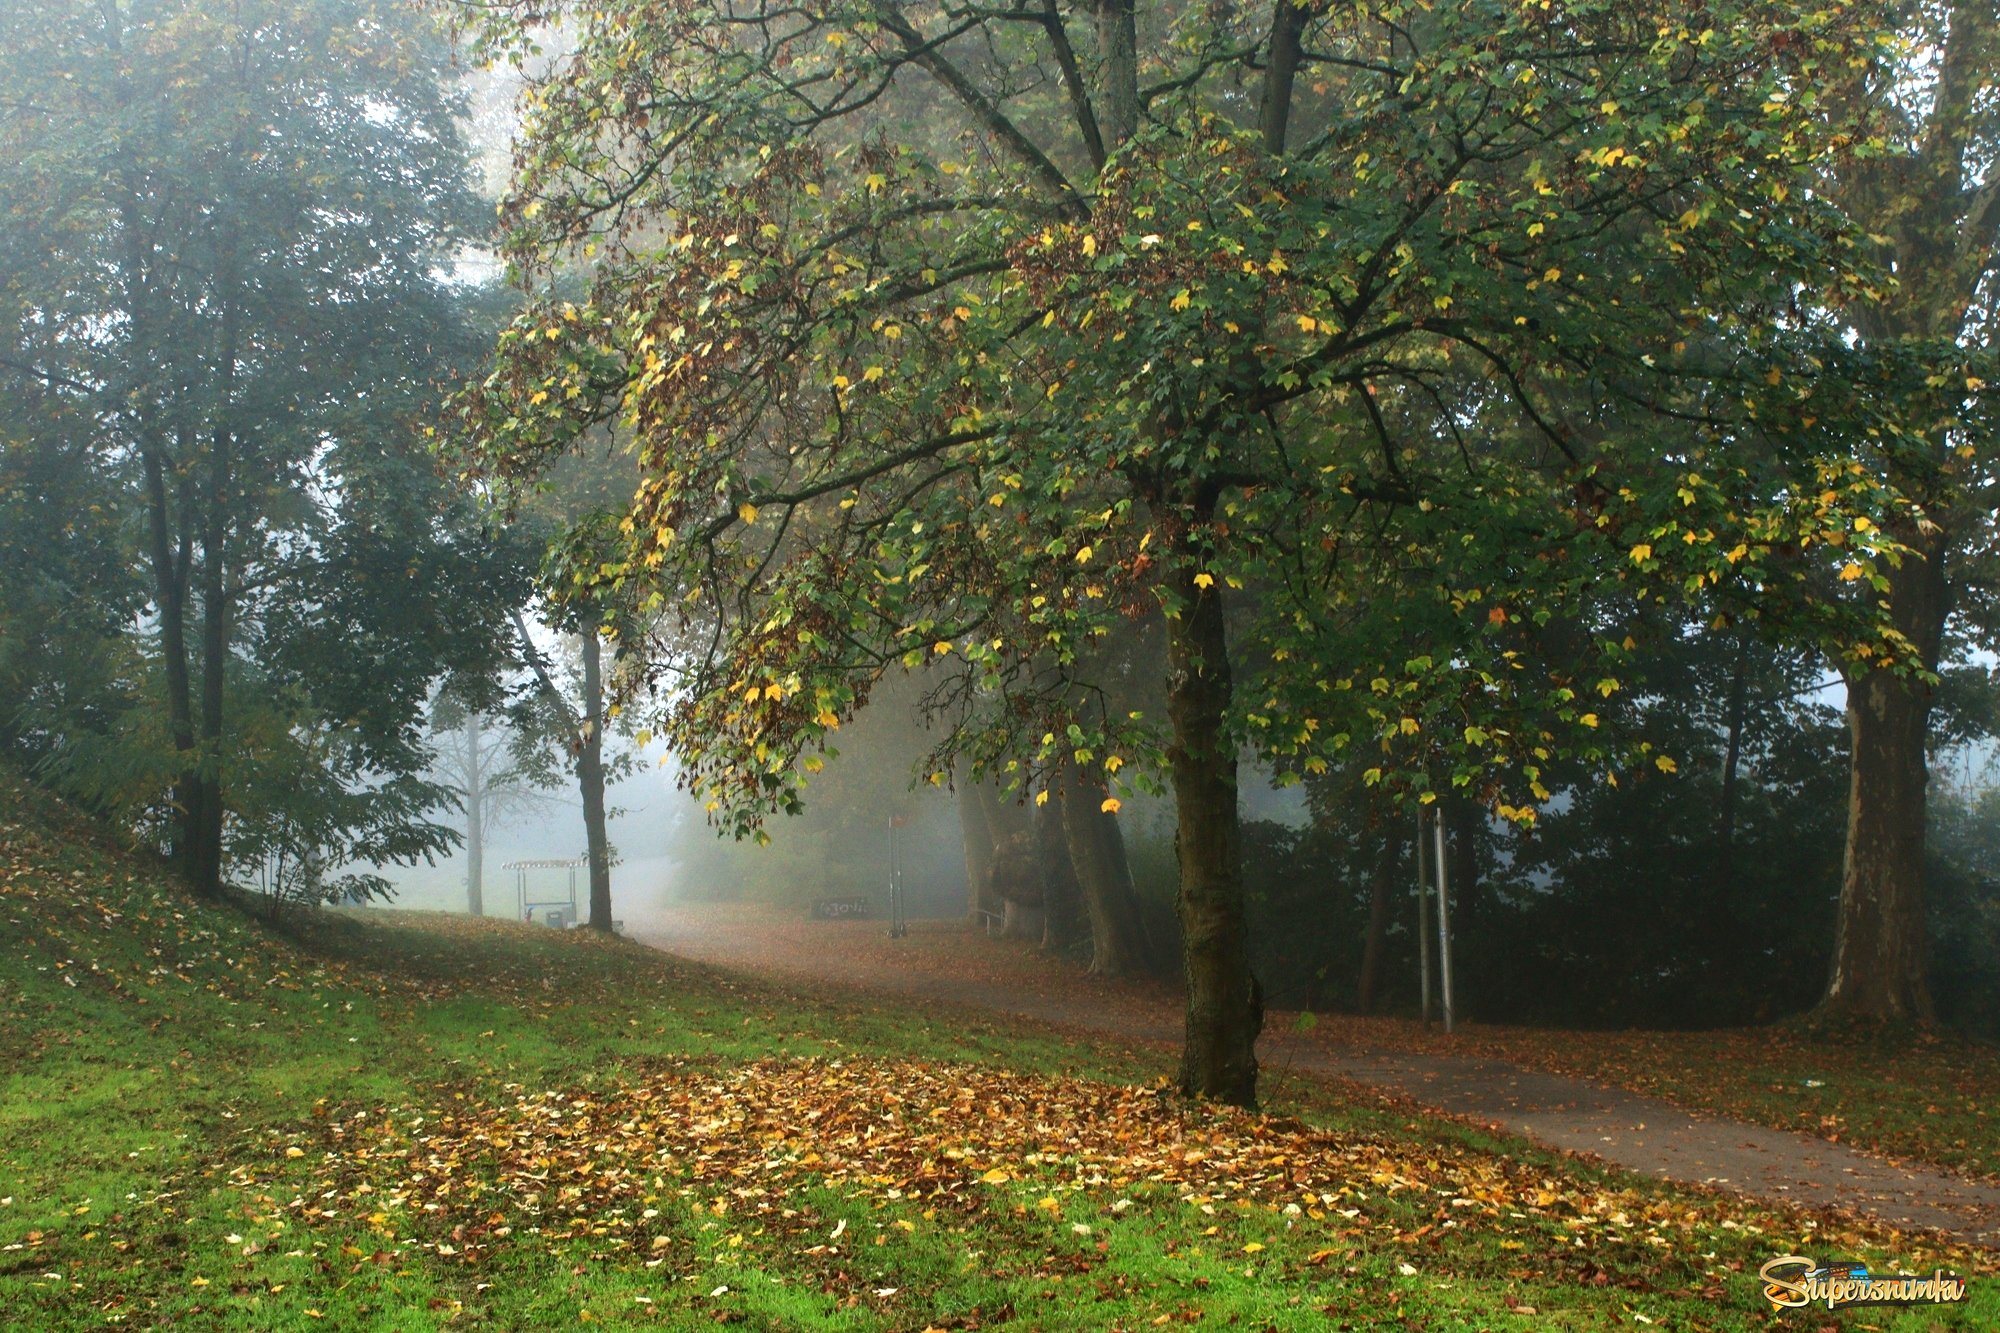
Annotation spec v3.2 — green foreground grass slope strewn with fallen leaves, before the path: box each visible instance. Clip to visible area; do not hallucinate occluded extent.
[0,777,2000,1331]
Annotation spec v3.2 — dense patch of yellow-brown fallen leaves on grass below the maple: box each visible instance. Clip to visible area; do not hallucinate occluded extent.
[232,1059,1976,1288]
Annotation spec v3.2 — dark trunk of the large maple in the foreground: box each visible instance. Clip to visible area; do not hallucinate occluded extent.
[1166,564,1262,1107]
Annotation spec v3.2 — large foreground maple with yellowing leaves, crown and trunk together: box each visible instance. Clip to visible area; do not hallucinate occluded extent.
[464,0,1890,1103]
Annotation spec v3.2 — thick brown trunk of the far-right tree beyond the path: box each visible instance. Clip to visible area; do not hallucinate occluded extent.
[1820,534,1946,1023]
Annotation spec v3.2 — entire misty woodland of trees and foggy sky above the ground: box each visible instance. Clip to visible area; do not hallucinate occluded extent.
[0,0,2000,1103]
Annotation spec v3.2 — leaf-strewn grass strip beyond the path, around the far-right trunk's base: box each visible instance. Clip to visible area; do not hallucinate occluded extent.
[1318,1015,2000,1183]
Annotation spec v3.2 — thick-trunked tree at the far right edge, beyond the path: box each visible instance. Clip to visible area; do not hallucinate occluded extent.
[1822,0,2000,1021]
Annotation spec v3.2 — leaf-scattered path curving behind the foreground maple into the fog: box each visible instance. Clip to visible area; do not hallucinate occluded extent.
[634,905,2000,1249]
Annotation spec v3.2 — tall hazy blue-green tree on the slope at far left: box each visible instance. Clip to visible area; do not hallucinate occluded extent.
[0,0,518,893]
